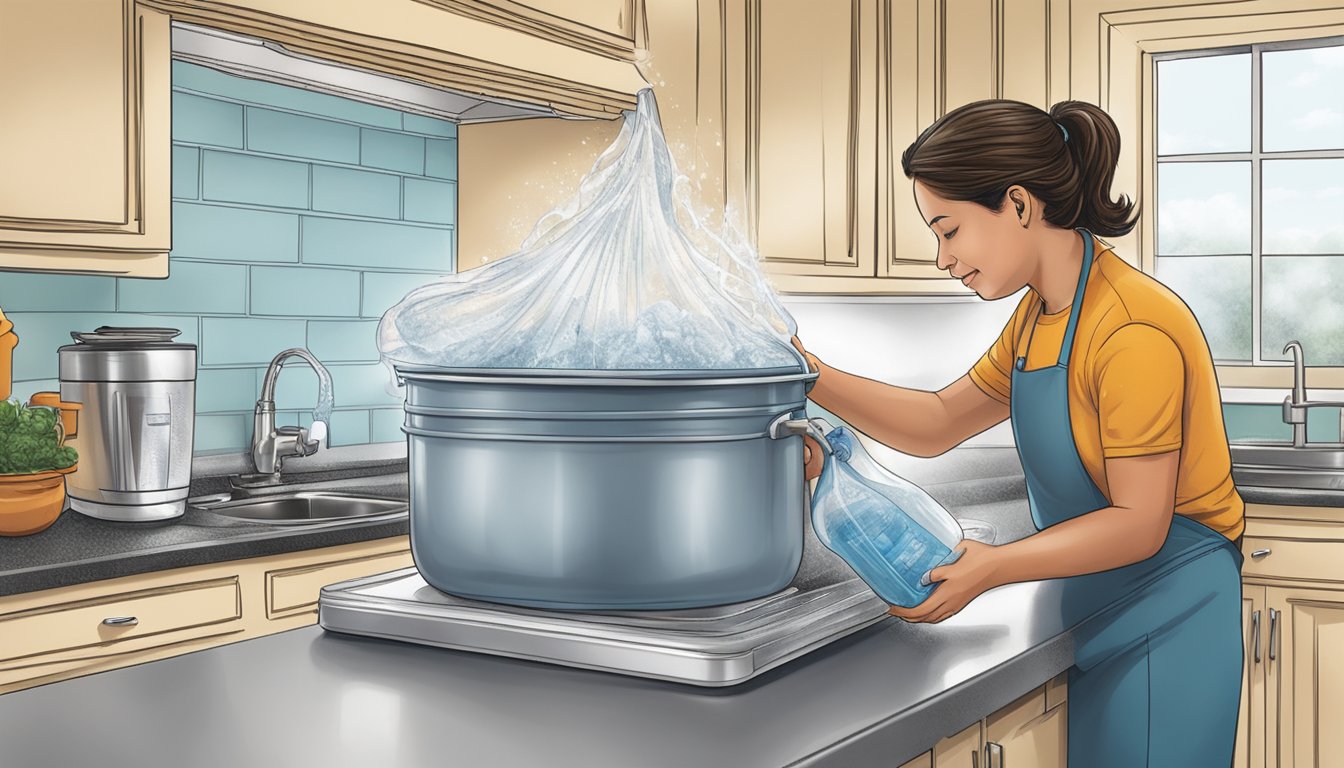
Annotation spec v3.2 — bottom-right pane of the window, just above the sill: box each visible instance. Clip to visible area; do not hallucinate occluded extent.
[1261,256,1344,366]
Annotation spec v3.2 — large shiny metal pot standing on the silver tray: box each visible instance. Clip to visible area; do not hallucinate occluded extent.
[396,367,816,609]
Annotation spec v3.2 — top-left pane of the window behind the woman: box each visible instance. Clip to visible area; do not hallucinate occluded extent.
[1157,54,1251,155]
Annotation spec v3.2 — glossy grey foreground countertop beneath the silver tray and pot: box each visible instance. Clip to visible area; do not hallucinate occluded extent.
[0,448,1236,768]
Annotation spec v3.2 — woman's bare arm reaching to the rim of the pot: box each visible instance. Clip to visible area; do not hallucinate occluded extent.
[808,354,1008,457]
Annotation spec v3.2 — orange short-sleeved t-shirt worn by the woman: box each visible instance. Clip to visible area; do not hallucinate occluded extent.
[970,239,1246,539]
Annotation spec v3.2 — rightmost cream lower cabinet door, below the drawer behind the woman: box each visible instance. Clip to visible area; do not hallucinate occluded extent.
[1265,586,1344,768]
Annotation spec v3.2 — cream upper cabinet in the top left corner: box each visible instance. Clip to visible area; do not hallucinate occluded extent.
[0,0,172,277]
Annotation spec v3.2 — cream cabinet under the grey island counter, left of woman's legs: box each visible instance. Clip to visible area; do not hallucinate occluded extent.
[902,673,1068,768]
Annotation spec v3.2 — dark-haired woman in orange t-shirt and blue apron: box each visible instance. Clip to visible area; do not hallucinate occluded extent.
[796,100,1245,768]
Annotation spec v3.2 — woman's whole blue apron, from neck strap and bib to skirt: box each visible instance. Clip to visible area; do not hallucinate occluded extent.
[1011,229,1242,768]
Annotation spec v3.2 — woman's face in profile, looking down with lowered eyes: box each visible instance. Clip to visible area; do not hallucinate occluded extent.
[914,179,1038,300]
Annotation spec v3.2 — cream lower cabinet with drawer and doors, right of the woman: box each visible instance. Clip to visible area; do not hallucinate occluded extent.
[1235,504,1344,768]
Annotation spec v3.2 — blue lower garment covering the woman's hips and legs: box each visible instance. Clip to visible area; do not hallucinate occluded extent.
[1068,546,1242,768]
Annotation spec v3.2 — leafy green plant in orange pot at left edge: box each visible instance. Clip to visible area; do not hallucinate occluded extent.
[0,399,79,537]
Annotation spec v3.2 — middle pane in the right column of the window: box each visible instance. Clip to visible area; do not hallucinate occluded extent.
[1261,160,1344,254]
